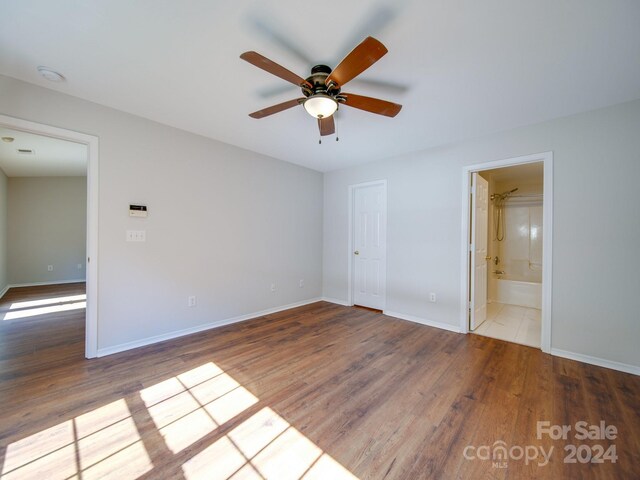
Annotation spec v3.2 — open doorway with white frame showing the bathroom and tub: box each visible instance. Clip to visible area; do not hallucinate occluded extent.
[461,153,552,351]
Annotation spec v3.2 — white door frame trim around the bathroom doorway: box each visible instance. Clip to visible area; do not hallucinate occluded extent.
[460,151,553,353]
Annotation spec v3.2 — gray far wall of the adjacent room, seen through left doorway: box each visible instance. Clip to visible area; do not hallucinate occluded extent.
[7,177,87,285]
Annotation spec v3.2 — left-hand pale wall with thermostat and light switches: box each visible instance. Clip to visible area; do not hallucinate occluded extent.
[0,76,323,350]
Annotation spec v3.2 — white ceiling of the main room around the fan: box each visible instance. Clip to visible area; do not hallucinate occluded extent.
[0,0,640,171]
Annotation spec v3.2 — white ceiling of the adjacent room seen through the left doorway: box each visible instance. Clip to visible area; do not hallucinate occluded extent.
[0,127,87,177]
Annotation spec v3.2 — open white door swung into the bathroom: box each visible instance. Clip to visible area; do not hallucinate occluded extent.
[469,173,489,330]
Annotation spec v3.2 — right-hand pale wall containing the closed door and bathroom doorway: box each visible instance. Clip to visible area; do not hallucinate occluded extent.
[323,97,640,367]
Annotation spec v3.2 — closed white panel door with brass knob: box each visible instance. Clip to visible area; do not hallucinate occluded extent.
[352,184,387,310]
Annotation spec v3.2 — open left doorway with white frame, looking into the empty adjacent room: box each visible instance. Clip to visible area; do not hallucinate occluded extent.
[0,116,98,358]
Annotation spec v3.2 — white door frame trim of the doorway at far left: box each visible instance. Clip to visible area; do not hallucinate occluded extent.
[0,115,99,358]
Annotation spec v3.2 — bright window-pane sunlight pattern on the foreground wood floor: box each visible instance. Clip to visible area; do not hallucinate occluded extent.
[0,362,357,480]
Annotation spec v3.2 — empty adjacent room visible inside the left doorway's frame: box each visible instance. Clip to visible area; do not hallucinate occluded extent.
[0,128,87,360]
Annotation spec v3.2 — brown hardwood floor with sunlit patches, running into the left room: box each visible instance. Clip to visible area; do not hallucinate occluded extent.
[0,285,640,480]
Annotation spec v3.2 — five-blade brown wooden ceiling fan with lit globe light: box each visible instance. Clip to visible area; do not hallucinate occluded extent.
[240,37,402,140]
